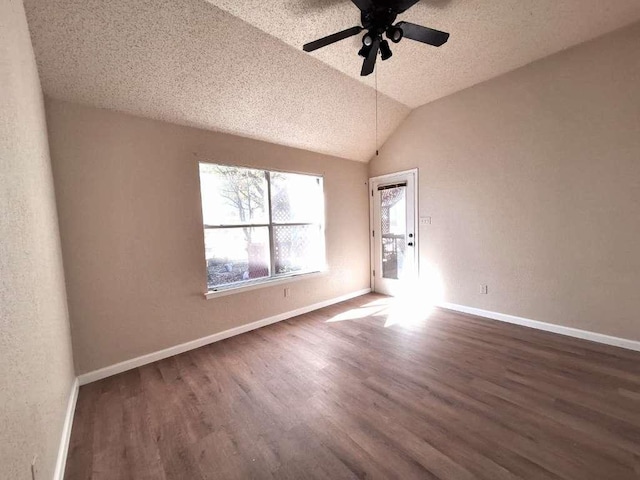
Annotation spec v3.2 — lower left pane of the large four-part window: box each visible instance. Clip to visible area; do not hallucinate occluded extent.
[204,227,270,289]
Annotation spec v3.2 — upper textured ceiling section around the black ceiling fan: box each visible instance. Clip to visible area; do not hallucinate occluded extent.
[208,0,640,108]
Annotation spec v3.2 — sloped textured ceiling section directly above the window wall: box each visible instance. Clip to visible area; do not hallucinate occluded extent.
[25,0,409,161]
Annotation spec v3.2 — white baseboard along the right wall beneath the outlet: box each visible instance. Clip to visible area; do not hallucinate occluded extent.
[438,303,640,352]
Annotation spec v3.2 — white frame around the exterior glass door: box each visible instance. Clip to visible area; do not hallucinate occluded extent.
[369,168,420,292]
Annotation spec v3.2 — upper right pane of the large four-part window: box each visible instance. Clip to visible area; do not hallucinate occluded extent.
[270,172,324,223]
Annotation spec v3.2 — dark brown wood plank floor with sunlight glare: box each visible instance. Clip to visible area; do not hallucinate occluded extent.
[65,295,640,480]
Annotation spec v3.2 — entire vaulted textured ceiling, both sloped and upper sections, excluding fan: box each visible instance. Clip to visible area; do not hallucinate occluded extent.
[25,0,640,161]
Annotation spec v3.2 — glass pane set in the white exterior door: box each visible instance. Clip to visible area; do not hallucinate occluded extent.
[379,186,407,279]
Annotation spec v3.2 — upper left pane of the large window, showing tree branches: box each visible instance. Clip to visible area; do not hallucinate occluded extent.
[200,163,269,225]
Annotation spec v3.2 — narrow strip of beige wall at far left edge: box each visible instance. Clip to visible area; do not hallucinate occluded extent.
[0,0,74,480]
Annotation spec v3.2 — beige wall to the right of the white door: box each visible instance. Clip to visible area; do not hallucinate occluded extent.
[370,24,640,340]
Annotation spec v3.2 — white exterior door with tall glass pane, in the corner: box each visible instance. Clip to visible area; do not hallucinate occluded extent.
[369,169,418,296]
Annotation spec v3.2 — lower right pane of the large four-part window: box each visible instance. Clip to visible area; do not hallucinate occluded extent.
[273,225,324,274]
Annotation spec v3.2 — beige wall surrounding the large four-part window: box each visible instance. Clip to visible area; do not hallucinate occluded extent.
[47,100,369,373]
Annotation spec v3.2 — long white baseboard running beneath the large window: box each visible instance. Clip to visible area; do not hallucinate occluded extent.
[78,288,371,385]
